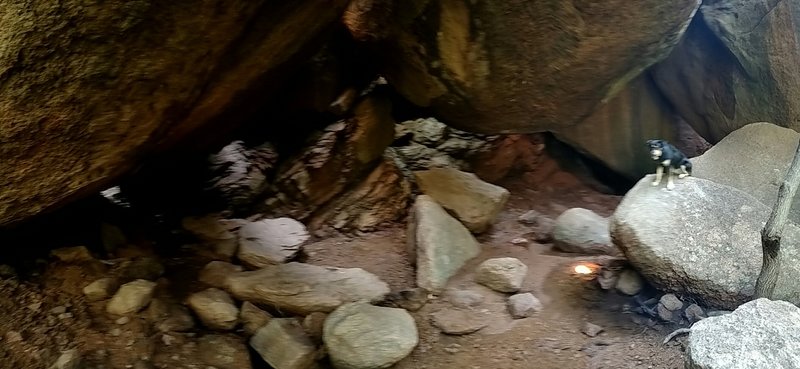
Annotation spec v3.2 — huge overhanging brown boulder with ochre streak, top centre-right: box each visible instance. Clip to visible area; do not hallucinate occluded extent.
[368,0,699,133]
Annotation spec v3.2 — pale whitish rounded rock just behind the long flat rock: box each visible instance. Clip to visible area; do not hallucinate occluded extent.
[237,218,311,268]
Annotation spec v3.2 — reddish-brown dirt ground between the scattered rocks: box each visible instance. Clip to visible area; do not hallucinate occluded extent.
[0,172,685,369]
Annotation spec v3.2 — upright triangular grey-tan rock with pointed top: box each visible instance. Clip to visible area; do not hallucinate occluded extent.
[408,195,480,293]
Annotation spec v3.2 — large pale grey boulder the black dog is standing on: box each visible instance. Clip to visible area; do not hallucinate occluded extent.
[609,175,800,310]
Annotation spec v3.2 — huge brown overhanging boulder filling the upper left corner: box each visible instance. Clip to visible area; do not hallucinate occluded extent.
[0,0,348,226]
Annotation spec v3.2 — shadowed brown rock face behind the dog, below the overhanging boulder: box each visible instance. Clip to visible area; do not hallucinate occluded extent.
[553,73,679,180]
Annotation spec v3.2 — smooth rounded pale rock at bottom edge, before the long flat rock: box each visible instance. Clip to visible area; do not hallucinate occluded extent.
[322,303,419,369]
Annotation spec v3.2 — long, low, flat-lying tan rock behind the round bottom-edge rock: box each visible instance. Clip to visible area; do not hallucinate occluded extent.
[225,262,389,315]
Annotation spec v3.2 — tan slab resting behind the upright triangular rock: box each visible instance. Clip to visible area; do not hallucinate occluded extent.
[414,168,509,233]
